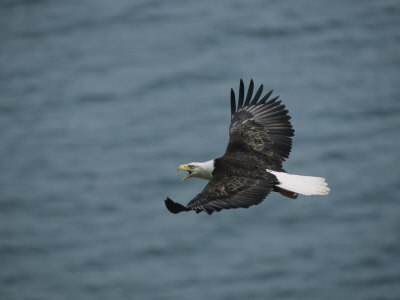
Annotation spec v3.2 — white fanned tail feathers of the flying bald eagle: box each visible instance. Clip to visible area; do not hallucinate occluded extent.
[267,169,331,196]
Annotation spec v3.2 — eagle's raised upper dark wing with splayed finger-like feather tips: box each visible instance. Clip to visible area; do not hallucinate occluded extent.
[225,80,294,167]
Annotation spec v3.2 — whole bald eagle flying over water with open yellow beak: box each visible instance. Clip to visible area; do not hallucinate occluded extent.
[165,80,330,214]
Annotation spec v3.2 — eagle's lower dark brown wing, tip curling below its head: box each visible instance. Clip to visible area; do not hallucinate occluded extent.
[165,176,274,215]
